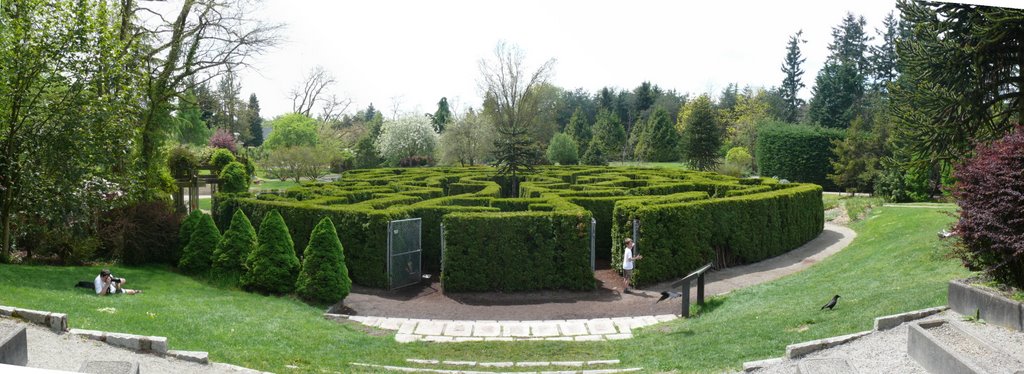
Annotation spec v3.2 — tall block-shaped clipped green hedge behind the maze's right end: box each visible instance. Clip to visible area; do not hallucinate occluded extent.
[757,123,845,191]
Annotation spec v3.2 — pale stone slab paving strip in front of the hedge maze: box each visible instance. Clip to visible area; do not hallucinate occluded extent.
[324,314,678,342]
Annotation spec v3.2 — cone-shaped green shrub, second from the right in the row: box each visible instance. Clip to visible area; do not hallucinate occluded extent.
[241,210,299,293]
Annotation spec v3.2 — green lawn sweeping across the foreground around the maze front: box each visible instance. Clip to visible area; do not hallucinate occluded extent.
[0,202,968,372]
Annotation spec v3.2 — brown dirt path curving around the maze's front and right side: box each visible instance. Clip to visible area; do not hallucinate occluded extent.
[345,223,856,320]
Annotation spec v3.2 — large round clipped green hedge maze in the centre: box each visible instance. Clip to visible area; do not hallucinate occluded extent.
[214,166,824,292]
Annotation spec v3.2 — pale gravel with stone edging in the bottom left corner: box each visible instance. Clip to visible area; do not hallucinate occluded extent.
[0,318,258,374]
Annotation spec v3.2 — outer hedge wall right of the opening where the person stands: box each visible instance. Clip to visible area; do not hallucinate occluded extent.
[611,183,824,285]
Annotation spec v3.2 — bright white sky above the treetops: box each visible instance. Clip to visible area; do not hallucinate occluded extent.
[230,0,921,119]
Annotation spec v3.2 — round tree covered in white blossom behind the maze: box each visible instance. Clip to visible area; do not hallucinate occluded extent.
[375,115,437,165]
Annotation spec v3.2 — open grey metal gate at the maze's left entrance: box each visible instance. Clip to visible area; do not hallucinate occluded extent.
[387,218,423,290]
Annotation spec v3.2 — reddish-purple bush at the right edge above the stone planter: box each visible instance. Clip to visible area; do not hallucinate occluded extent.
[953,125,1024,289]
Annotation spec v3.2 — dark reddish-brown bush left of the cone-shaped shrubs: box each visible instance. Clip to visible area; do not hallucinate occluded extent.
[99,197,183,265]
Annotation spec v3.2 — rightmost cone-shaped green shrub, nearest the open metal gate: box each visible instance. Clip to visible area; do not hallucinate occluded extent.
[295,217,352,303]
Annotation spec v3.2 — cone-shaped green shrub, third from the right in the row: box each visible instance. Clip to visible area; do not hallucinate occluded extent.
[213,209,256,283]
